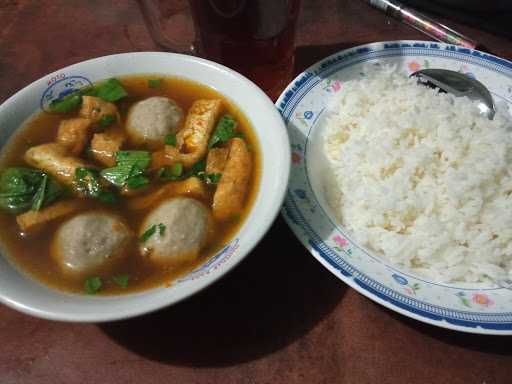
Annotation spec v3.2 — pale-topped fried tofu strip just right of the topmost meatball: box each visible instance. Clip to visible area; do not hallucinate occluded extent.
[176,99,222,167]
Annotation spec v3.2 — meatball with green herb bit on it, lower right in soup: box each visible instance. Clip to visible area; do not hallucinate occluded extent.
[139,197,210,264]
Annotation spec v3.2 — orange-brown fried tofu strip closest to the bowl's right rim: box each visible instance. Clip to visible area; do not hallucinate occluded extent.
[212,138,252,220]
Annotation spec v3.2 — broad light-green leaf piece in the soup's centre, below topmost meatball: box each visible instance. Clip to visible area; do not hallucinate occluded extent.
[101,151,151,189]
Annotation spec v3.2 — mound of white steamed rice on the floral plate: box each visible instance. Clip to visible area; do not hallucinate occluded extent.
[323,67,512,282]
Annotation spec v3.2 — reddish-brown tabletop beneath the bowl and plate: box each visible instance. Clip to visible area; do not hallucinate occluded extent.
[0,0,512,384]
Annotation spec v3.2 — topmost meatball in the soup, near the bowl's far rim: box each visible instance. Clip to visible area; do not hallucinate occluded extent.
[126,96,183,147]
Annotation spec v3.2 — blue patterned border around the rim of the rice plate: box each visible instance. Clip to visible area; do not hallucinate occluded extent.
[276,41,512,334]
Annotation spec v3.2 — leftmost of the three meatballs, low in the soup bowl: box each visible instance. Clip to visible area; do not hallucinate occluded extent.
[51,212,130,274]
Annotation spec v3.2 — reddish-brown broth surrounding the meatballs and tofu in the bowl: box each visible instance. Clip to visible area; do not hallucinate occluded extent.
[0,75,261,294]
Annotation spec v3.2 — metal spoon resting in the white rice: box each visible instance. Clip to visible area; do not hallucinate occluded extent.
[411,69,496,120]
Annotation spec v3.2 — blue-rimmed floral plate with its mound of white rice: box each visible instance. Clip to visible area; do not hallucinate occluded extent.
[276,41,512,334]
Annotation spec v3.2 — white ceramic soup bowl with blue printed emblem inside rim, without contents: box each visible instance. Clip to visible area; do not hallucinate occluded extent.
[0,52,290,322]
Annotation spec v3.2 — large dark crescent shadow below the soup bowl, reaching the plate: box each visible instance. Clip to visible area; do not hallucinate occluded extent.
[99,217,347,366]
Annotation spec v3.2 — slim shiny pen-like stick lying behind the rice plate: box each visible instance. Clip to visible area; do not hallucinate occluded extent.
[367,0,478,49]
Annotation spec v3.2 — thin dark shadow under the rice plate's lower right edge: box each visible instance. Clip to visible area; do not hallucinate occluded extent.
[382,303,512,356]
